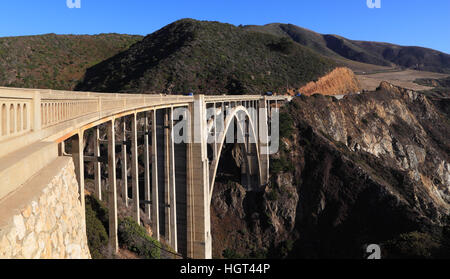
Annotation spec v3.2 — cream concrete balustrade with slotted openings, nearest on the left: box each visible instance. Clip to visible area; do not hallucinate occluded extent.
[0,88,193,143]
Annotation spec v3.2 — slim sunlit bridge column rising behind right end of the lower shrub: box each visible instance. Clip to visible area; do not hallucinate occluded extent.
[151,110,160,241]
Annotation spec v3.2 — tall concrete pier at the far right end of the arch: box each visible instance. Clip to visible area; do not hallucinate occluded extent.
[258,98,270,185]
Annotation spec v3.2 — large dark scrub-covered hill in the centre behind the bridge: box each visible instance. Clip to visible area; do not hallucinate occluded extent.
[76,19,336,94]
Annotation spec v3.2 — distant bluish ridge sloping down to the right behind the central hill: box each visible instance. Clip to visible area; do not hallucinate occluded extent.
[243,23,450,73]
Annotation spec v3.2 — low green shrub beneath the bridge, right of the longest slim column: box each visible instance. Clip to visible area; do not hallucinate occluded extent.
[118,218,162,259]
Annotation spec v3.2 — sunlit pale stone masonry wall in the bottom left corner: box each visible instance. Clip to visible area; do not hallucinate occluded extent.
[0,157,90,259]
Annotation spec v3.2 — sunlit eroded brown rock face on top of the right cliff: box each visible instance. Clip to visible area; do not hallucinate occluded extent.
[290,82,450,210]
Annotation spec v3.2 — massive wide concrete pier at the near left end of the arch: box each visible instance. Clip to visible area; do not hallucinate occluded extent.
[187,95,212,259]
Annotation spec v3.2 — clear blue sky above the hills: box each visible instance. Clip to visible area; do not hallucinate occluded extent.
[0,0,450,53]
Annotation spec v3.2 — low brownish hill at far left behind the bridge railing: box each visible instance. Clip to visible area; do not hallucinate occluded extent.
[0,34,142,90]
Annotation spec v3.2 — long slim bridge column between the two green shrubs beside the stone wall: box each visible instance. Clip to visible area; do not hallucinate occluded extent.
[107,119,119,254]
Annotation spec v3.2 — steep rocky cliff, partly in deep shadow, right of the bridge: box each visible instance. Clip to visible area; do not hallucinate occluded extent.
[212,83,450,258]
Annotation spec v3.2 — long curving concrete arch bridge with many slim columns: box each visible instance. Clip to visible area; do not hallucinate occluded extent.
[0,88,291,258]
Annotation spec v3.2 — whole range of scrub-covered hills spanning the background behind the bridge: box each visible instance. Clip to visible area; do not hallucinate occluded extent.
[0,19,450,94]
